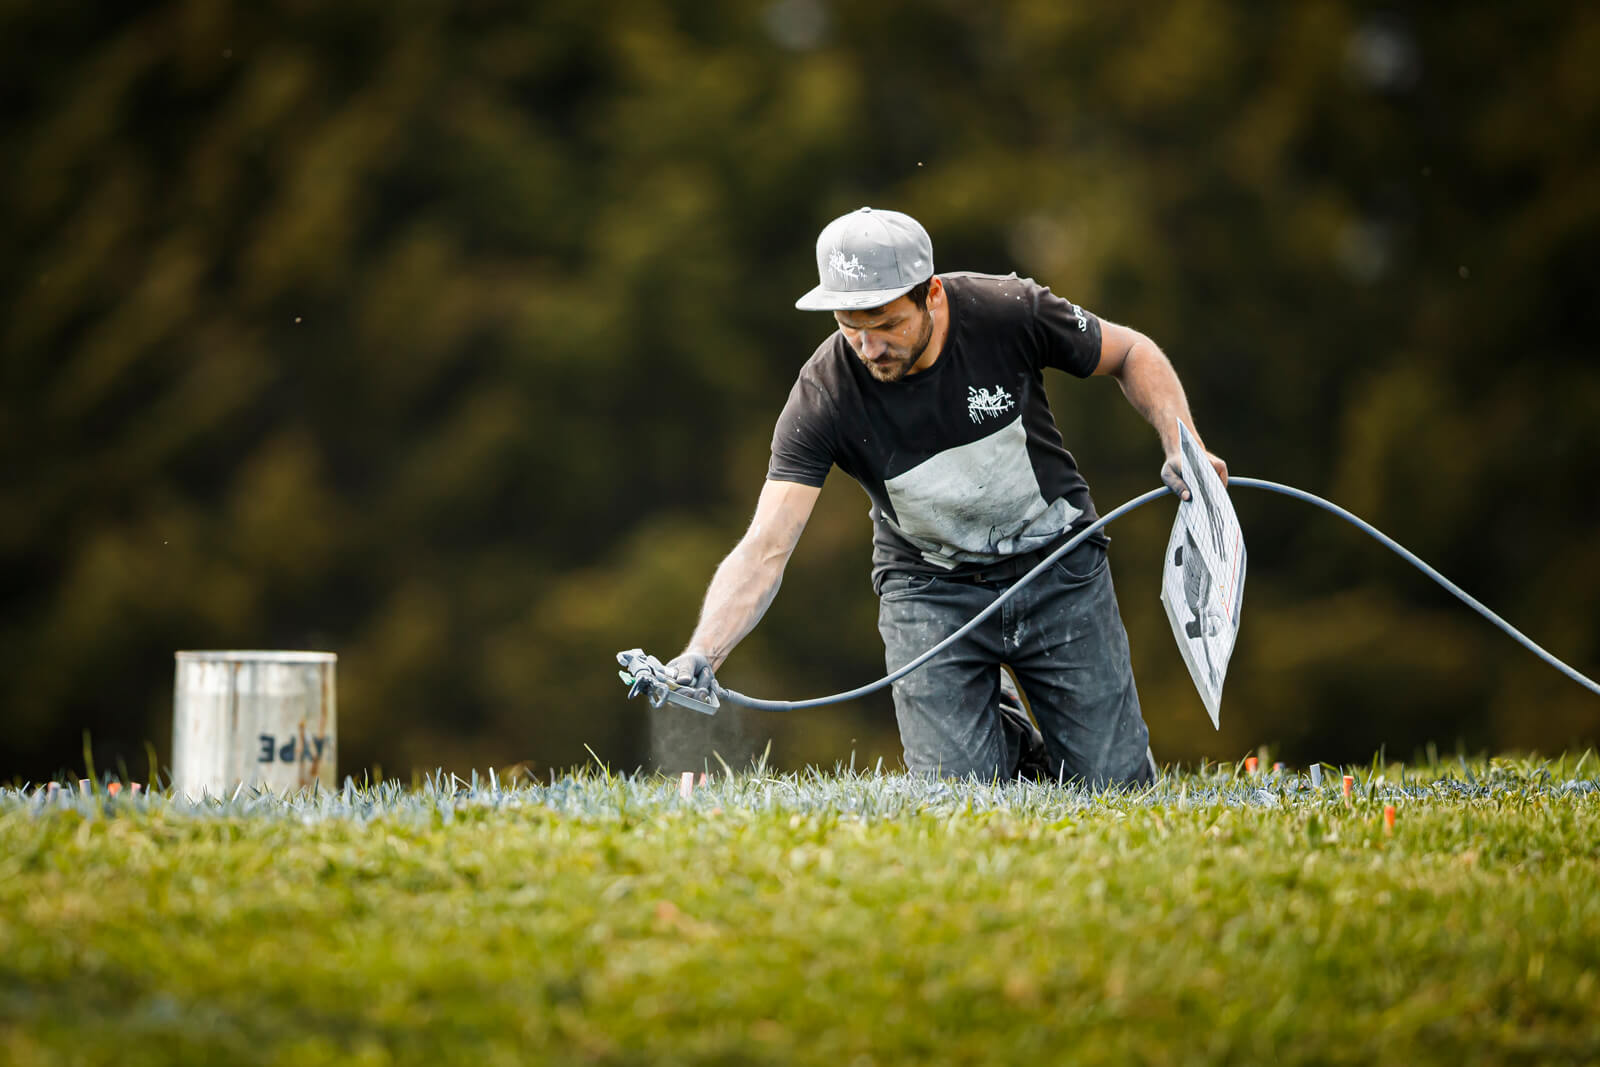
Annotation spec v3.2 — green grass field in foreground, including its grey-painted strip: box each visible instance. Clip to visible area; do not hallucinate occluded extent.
[0,758,1600,1067]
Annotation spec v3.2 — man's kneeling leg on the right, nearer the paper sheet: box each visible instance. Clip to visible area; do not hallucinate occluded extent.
[1002,544,1154,789]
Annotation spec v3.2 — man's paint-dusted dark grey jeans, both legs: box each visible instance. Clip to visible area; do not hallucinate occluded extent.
[878,542,1152,789]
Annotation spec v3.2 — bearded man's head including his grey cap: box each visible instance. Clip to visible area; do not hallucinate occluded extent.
[795,208,944,382]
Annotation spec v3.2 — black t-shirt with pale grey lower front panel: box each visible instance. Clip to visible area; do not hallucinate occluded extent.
[766,272,1101,585]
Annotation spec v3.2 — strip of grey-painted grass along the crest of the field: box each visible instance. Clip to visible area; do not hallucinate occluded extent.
[0,755,1600,824]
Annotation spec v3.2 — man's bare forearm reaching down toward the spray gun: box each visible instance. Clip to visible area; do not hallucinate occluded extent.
[674,480,821,670]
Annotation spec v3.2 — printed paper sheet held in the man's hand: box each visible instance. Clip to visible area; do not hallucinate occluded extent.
[1162,422,1245,728]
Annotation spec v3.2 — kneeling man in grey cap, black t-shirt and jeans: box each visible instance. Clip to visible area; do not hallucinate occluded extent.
[669,208,1227,787]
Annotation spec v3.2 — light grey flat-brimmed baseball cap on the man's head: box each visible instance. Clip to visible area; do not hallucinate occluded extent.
[795,208,933,312]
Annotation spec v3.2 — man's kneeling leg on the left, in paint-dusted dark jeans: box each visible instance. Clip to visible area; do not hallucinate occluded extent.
[878,574,1019,779]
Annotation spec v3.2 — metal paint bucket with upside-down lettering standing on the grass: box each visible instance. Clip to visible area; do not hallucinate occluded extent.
[173,651,339,800]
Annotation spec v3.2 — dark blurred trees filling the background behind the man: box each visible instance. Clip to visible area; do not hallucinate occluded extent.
[0,0,1600,779]
